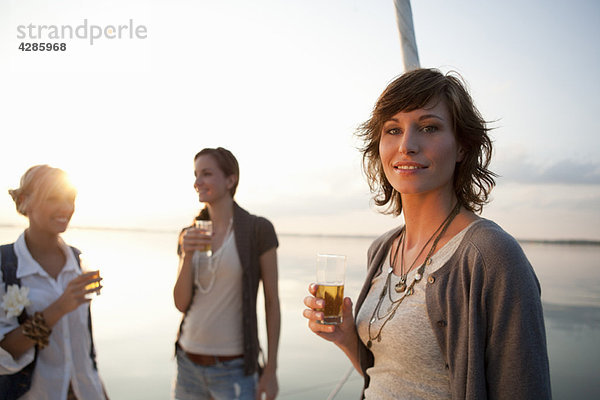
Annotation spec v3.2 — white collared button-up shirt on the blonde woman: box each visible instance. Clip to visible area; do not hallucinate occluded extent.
[0,233,105,400]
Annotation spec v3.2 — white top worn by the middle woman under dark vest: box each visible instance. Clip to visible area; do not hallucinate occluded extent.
[179,230,244,356]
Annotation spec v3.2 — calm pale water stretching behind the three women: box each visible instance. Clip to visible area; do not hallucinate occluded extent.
[0,228,600,400]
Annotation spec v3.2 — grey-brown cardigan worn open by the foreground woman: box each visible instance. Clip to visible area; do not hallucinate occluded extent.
[355,220,552,400]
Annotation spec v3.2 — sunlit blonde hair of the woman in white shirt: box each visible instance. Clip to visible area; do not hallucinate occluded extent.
[8,164,77,216]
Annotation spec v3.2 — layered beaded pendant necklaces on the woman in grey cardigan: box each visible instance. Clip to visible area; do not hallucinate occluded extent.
[367,202,460,348]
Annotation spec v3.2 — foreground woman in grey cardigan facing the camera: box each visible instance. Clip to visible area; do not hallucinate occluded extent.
[304,69,551,400]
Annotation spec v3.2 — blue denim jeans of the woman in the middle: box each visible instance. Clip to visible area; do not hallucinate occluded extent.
[175,348,258,400]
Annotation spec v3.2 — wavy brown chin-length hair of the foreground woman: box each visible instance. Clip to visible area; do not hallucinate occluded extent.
[356,68,497,215]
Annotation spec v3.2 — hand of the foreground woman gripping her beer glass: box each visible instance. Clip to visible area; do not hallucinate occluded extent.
[302,283,356,347]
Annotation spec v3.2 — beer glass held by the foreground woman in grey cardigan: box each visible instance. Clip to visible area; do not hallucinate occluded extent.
[316,254,346,325]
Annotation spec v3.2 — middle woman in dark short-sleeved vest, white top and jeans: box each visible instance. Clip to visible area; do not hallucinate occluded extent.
[173,147,280,400]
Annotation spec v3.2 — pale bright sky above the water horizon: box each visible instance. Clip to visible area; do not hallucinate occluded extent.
[0,0,600,240]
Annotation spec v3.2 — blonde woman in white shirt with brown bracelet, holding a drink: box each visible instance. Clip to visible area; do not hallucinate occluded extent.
[0,165,106,400]
